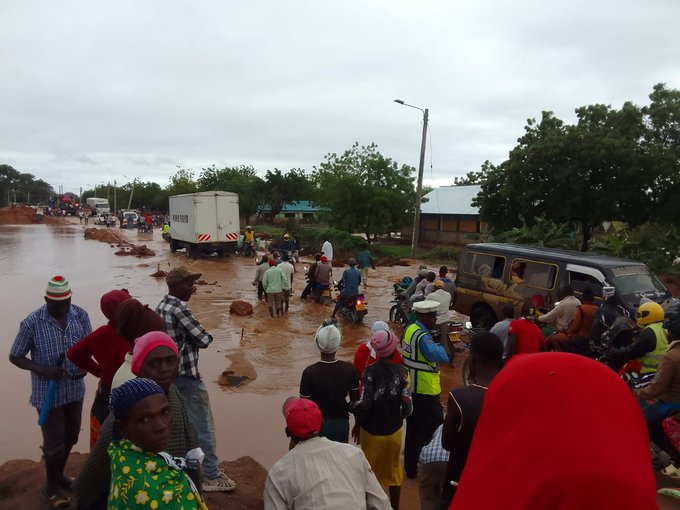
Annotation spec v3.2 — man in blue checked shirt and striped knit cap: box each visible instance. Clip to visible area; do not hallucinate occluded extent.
[9,276,92,508]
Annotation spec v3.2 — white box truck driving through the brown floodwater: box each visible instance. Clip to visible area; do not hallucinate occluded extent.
[169,191,240,257]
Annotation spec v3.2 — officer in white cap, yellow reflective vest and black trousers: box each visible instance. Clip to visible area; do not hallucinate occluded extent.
[402,300,449,478]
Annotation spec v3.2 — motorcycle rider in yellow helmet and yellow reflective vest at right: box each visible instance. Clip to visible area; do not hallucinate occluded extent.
[606,301,668,374]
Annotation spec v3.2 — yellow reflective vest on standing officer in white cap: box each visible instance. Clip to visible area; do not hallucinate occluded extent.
[401,323,442,395]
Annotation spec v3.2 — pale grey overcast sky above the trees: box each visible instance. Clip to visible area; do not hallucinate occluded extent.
[0,0,680,193]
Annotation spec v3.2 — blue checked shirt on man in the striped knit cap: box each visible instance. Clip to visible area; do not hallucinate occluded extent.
[10,305,92,409]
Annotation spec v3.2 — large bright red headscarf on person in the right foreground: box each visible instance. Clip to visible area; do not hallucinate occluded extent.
[449,353,657,510]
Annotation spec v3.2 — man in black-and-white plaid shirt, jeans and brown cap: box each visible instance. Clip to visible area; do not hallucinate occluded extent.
[156,267,236,492]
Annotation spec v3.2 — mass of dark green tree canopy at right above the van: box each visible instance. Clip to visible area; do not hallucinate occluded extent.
[472,84,680,250]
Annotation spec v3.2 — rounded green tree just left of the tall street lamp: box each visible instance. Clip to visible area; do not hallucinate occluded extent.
[315,143,415,240]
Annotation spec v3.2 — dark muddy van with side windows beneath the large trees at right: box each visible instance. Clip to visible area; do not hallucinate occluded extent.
[454,243,676,329]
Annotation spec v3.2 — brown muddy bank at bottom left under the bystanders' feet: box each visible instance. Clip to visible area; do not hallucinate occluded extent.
[0,453,267,510]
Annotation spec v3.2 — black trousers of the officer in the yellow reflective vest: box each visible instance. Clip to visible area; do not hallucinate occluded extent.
[404,393,444,478]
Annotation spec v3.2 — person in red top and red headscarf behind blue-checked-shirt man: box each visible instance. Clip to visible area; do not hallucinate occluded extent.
[66,289,131,448]
